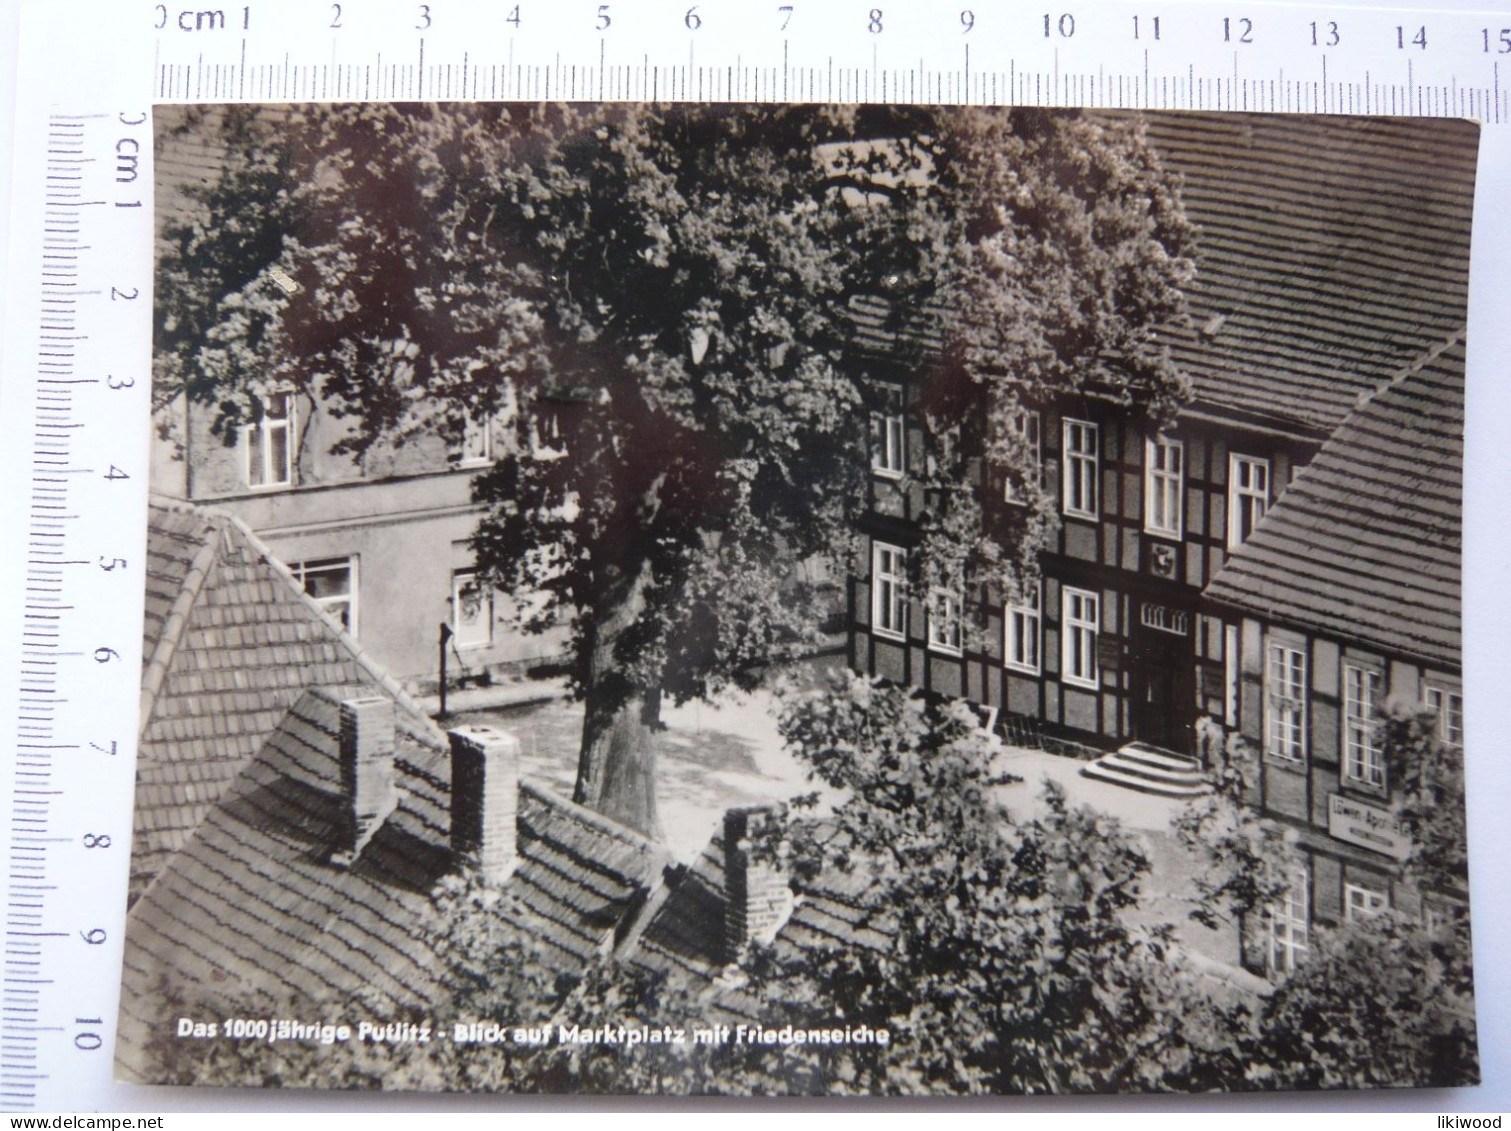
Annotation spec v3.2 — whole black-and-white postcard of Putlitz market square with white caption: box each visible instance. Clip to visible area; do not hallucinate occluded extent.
[115,103,1479,1096]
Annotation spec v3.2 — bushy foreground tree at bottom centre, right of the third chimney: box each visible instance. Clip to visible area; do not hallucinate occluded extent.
[740,676,1244,1093]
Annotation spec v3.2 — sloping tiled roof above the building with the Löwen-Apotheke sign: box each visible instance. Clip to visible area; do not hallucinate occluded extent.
[1206,335,1464,670]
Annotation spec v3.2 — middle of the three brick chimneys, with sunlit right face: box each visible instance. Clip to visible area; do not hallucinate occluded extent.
[447,726,520,883]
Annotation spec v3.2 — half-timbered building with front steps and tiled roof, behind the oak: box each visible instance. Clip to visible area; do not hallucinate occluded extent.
[849,115,1478,767]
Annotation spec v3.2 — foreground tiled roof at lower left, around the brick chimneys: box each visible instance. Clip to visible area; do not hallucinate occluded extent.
[118,687,669,1078]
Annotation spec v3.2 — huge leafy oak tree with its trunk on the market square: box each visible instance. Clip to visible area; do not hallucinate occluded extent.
[157,106,1191,829]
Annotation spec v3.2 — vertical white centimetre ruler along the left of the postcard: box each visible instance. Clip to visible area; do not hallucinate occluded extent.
[0,5,153,1110]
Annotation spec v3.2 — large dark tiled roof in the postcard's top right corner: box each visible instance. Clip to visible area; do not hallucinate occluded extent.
[1147,113,1478,432]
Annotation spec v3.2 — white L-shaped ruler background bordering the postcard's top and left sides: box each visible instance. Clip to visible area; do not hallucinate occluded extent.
[0,0,1511,1111]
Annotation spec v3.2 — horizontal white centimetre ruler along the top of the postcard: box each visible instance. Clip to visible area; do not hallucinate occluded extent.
[151,0,1511,122]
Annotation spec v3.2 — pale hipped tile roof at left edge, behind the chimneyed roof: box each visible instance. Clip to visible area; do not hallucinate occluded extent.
[131,500,440,898]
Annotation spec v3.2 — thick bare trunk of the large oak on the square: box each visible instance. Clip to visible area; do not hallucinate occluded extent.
[573,571,663,840]
